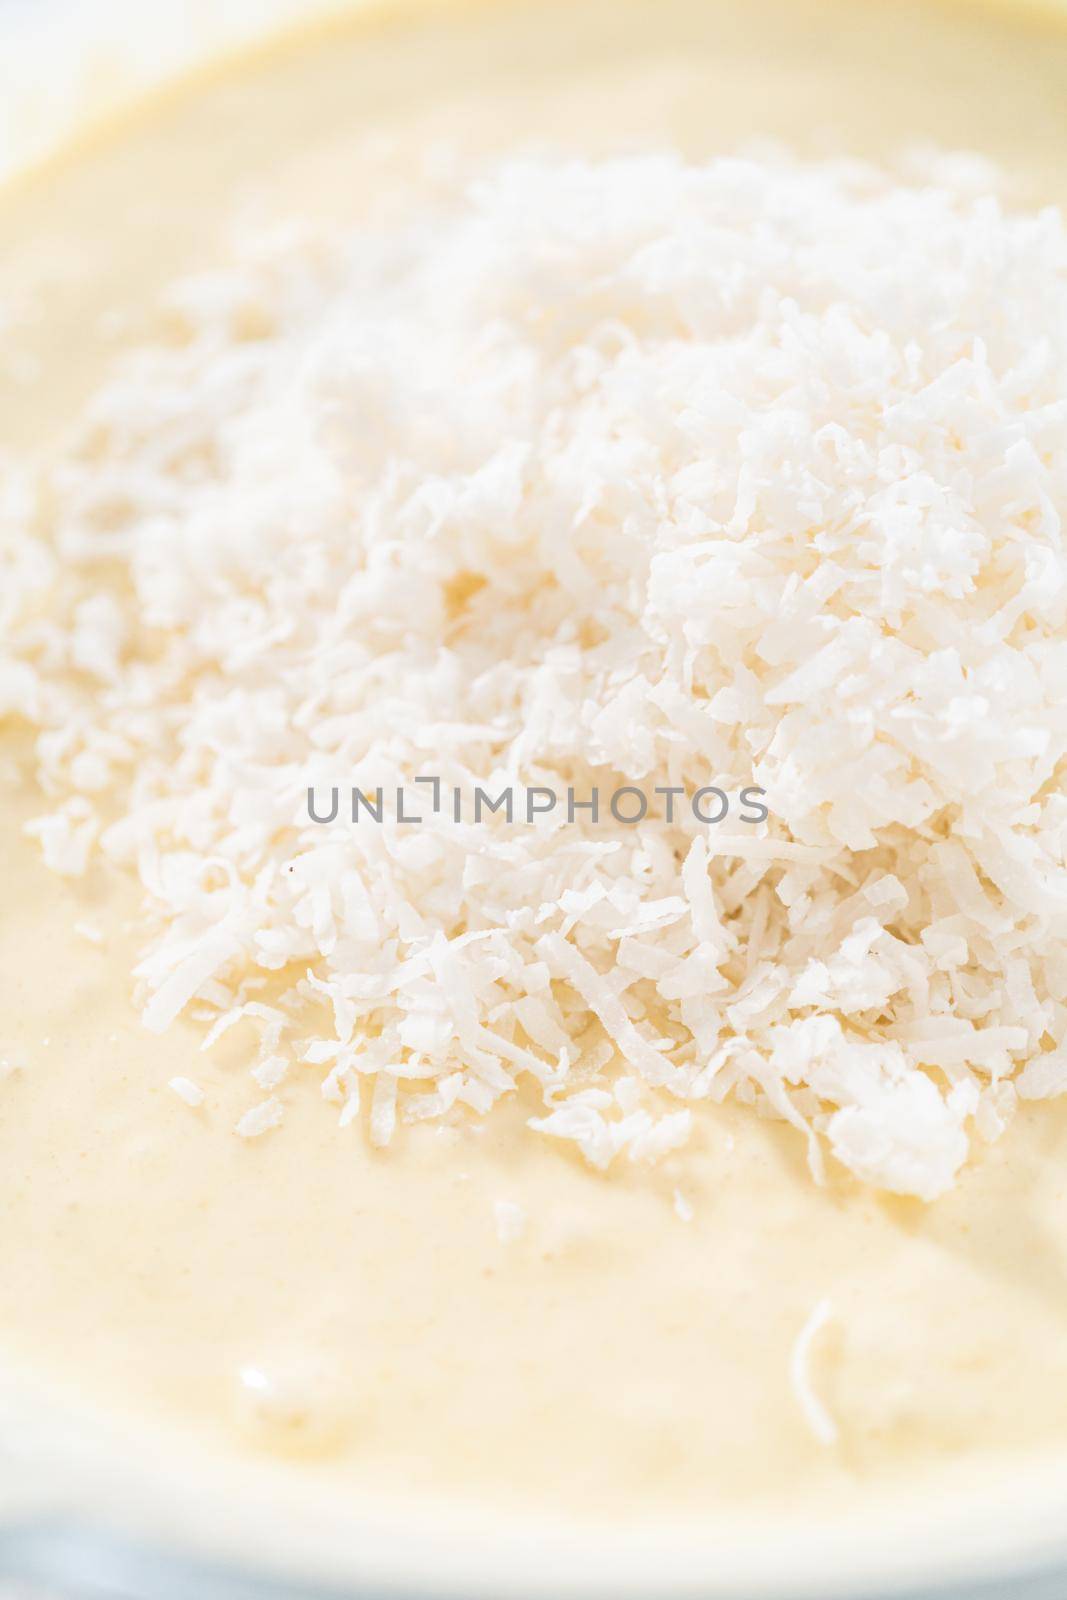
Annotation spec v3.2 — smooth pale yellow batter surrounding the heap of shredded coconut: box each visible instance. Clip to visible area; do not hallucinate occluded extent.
[0,0,1067,1580]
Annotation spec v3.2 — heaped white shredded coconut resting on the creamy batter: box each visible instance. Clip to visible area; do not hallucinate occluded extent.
[0,155,1067,1198]
